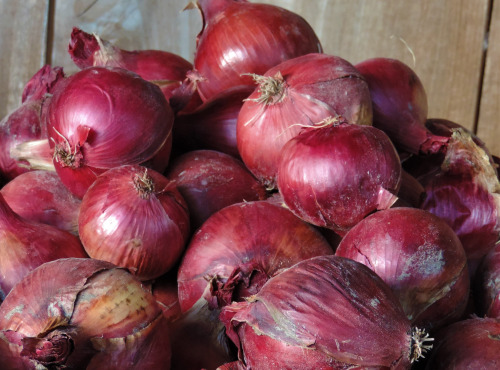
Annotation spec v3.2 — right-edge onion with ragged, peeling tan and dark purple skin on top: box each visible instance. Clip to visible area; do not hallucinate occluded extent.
[419,129,500,266]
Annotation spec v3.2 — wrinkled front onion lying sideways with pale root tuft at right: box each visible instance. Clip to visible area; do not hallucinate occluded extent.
[221,256,431,370]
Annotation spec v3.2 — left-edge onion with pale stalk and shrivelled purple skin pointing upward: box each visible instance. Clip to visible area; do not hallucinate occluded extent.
[0,65,64,181]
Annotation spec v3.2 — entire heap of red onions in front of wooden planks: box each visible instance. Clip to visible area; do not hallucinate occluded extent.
[0,0,500,370]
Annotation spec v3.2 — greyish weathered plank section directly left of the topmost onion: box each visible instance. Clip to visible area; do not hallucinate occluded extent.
[52,0,201,73]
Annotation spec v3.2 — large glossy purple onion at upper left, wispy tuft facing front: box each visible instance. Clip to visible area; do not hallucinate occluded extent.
[47,67,174,198]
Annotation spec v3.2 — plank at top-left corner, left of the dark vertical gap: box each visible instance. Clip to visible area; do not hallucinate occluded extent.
[0,0,49,119]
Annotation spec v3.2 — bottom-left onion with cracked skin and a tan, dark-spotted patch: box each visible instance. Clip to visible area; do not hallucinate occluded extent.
[0,258,171,369]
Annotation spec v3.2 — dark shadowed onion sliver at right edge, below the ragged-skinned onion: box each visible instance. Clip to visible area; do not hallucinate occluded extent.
[473,243,500,319]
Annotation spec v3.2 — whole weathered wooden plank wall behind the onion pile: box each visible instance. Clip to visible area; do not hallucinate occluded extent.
[0,0,500,156]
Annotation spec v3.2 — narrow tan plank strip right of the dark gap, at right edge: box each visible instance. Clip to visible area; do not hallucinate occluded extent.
[477,1,500,157]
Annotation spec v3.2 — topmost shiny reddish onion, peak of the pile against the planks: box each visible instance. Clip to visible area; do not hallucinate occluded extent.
[193,0,323,101]
